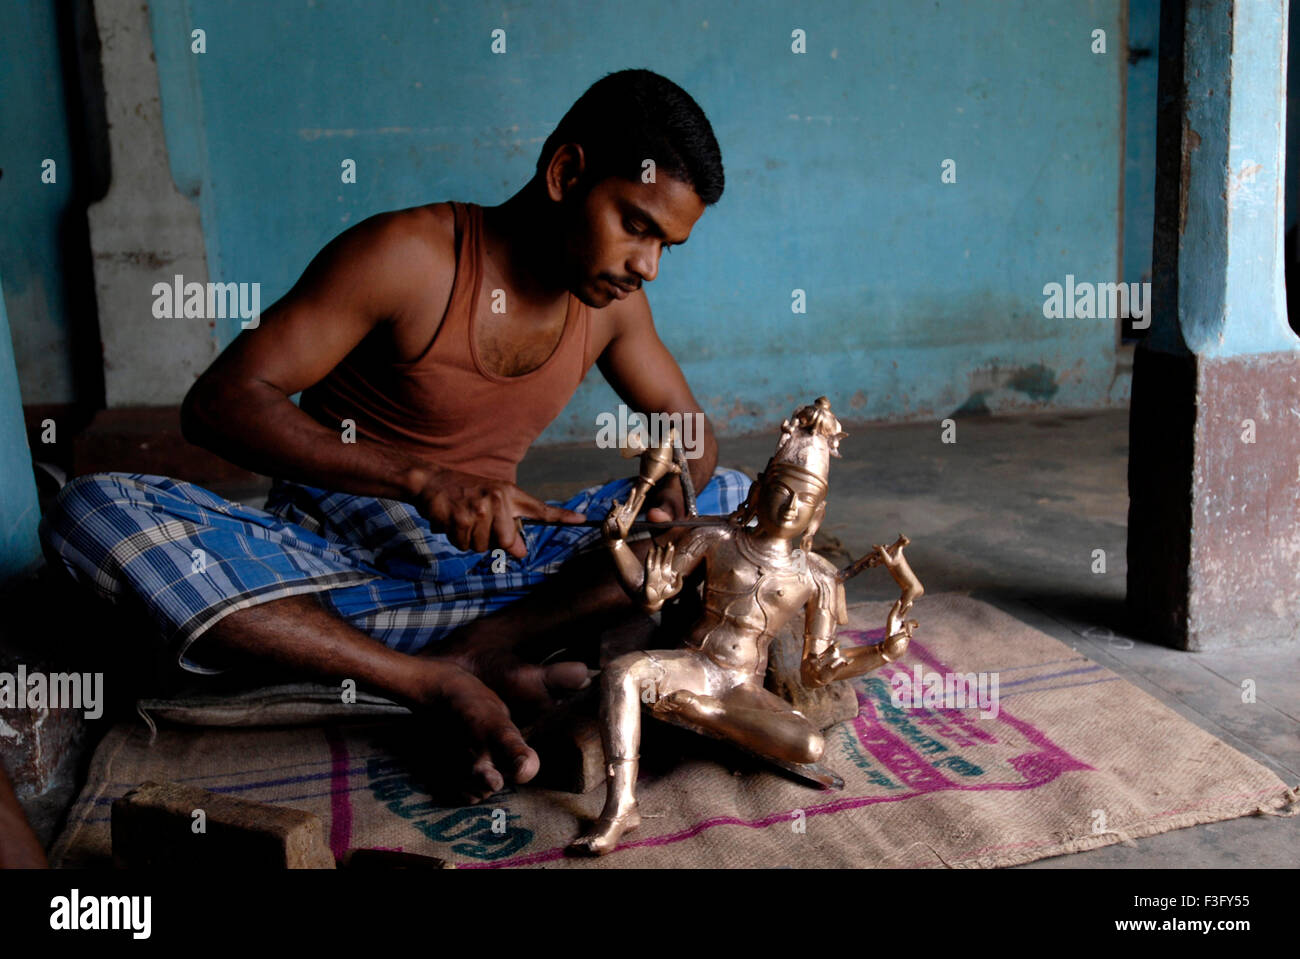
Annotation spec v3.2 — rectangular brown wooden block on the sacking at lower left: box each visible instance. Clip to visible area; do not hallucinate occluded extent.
[112,782,335,869]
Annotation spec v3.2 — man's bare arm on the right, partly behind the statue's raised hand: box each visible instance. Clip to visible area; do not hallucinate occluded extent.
[597,290,718,516]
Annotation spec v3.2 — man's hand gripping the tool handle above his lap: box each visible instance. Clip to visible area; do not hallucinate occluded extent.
[411,468,586,559]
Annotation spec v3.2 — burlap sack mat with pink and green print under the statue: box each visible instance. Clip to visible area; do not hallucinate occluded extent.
[52,594,1300,868]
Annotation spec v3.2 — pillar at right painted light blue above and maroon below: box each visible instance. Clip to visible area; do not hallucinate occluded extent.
[1128,0,1300,650]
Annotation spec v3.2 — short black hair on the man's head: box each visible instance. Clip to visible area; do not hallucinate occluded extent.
[537,70,723,205]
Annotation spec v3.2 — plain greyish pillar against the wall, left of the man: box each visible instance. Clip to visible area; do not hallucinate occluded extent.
[88,0,217,407]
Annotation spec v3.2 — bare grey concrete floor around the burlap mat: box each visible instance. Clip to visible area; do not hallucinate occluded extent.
[20,411,1300,868]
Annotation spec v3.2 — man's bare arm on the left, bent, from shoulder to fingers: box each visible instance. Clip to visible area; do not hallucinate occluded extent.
[181,208,584,556]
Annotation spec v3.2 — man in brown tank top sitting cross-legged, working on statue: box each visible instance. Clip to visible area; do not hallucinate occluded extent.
[42,70,749,799]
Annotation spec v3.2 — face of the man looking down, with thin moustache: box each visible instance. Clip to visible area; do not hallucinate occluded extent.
[553,166,705,309]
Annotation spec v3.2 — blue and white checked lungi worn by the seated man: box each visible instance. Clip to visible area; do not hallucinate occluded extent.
[40,469,750,673]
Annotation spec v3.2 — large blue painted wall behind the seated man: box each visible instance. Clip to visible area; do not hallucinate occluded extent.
[144,0,1123,439]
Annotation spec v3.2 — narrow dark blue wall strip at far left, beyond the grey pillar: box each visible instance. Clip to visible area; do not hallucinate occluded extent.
[0,0,78,403]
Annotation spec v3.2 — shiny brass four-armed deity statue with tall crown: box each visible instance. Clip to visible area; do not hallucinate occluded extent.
[571,396,923,855]
